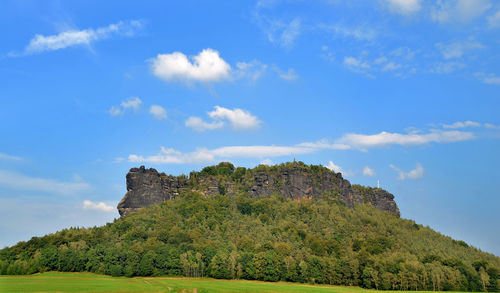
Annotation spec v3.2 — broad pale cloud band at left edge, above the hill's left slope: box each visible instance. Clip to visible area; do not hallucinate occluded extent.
[0,170,90,195]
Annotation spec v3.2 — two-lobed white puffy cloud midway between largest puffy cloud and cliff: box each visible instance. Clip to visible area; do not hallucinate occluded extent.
[185,106,261,131]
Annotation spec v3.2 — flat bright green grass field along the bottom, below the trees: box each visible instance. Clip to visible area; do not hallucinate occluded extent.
[0,272,468,293]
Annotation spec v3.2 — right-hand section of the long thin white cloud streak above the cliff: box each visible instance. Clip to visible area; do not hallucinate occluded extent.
[336,130,475,150]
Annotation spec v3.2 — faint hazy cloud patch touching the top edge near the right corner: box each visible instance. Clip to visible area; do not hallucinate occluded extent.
[431,0,492,23]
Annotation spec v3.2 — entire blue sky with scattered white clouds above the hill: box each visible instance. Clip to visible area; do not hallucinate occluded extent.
[0,0,500,255]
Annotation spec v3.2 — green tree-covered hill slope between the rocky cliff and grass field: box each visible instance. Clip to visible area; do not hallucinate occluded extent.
[0,162,500,291]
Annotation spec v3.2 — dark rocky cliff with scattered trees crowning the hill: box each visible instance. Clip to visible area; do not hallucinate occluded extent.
[118,162,399,216]
